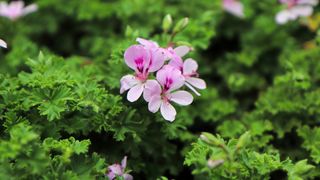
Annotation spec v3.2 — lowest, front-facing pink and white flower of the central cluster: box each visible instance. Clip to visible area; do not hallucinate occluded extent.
[144,65,193,122]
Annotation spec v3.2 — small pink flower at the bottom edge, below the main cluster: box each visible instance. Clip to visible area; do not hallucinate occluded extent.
[107,156,133,180]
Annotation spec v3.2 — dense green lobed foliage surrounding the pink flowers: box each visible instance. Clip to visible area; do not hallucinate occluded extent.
[0,0,320,180]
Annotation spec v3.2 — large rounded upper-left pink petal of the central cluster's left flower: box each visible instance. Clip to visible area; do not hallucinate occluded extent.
[124,45,150,71]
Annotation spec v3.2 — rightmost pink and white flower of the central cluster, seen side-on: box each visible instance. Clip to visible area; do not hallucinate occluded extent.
[169,58,207,96]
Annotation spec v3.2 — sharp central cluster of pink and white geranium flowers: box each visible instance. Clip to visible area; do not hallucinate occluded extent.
[120,38,206,121]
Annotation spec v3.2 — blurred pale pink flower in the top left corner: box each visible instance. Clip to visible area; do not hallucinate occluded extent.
[0,1,38,20]
